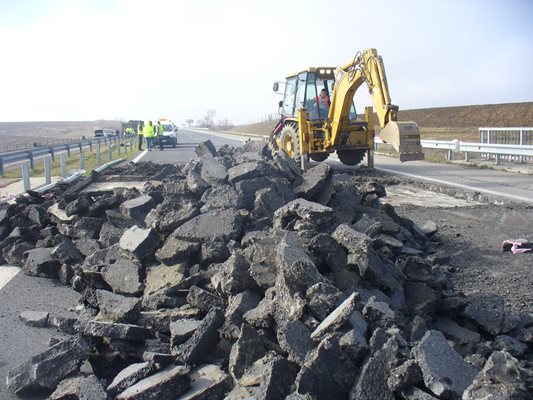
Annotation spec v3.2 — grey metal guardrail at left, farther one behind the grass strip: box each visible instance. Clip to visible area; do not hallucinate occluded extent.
[0,135,136,176]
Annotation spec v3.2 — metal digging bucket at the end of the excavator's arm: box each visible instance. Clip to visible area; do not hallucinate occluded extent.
[379,121,424,162]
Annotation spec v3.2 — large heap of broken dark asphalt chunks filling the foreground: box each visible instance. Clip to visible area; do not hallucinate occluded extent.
[0,138,533,400]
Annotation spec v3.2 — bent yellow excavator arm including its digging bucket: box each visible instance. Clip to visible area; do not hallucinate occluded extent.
[327,49,424,161]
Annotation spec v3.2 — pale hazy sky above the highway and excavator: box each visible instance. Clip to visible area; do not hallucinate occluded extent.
[0,0,533,124]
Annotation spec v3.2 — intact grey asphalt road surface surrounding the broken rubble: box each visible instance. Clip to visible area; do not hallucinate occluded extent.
[0,129,533,400]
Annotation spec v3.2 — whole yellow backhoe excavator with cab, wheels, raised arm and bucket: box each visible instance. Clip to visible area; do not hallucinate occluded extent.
[270,49,424,169]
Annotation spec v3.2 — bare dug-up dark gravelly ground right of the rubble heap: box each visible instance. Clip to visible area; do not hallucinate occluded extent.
[382,178,533,313]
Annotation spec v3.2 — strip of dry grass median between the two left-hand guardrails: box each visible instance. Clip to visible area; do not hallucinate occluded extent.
[2,142,137,180]
